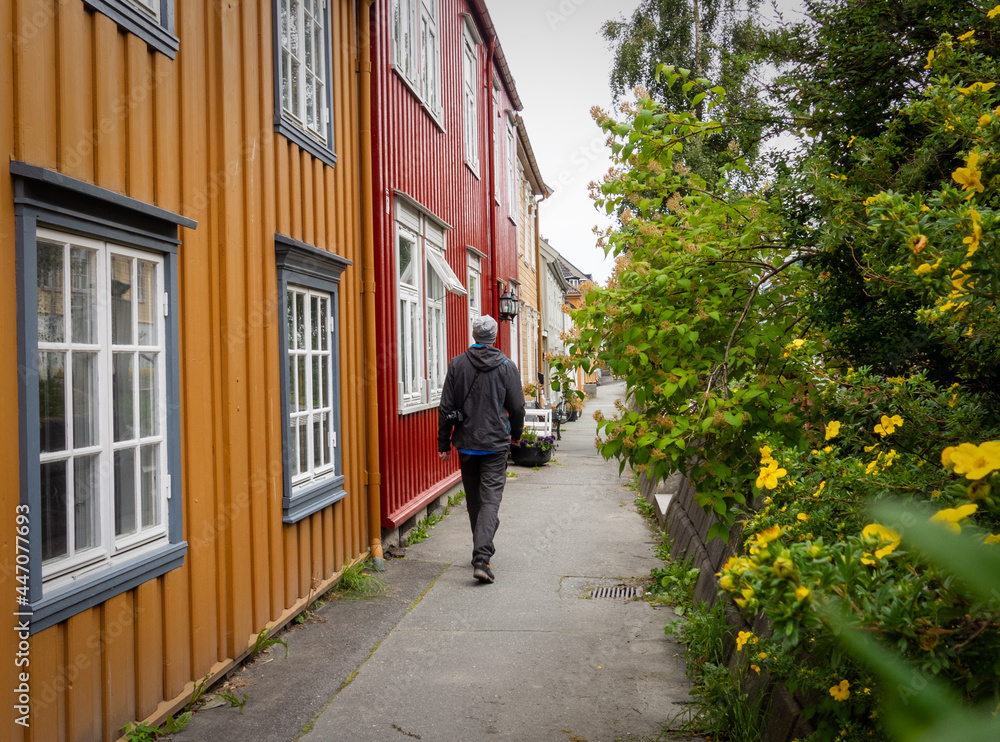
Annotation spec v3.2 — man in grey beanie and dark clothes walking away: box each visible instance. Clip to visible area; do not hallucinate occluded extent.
[438,315,524,583]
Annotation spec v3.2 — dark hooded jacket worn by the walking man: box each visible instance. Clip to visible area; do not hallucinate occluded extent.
[438,345,524,451]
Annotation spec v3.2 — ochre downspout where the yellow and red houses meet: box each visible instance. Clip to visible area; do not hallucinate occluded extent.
[358,0,385,571]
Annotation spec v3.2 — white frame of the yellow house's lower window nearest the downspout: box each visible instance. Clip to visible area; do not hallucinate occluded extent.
[285,284,337,493]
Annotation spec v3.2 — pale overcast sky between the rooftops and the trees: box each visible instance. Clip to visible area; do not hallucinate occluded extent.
[488,0,799,283]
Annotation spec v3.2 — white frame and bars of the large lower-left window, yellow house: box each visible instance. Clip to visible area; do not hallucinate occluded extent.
[36,228,170,590]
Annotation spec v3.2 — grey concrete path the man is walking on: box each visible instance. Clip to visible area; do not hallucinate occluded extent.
[175,384,689,742]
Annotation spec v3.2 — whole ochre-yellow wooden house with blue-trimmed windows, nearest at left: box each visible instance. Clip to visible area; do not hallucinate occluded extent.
[0,0,381,742]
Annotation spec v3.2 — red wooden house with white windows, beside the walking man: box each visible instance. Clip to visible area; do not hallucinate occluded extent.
[371,0,521,529]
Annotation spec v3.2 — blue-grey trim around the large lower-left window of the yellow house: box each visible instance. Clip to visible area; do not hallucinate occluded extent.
[10,161,191,633]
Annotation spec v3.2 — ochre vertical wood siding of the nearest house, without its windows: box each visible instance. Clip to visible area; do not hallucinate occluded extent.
[0,0,369,742]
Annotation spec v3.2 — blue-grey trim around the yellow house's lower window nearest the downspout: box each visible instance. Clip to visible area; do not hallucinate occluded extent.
[274,234,352,523]
